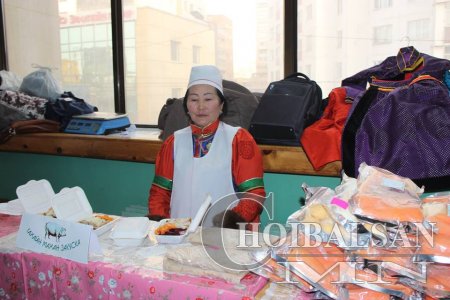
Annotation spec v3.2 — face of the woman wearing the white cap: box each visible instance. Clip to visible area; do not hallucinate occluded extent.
[186,84,223,128]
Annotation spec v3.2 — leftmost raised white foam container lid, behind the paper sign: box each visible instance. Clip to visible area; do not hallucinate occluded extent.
[16,179,55,214]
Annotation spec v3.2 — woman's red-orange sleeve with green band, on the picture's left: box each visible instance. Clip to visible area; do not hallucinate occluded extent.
[148,135,174,218]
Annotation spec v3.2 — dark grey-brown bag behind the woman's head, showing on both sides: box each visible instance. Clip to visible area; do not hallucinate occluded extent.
[158,80,258,140]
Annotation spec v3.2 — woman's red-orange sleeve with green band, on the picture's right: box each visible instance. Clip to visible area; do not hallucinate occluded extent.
[232,128,266,222]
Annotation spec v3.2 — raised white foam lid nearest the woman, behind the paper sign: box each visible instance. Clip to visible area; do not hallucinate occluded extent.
[52,186,93,222]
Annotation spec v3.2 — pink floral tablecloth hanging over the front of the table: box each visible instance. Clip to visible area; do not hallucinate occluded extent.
[0,214,267,300]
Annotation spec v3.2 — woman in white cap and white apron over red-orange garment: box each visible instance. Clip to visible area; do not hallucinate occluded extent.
[148,65,265,228]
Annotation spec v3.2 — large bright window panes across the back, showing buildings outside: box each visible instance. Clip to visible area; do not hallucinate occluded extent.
[3,0,442,125]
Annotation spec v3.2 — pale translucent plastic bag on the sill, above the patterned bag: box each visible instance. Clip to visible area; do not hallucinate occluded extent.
[20,67,62,100]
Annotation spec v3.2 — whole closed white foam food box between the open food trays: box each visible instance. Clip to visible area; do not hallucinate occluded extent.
[109,217,151,247]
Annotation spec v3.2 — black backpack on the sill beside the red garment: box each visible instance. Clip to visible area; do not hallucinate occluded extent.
[249,73,323,146]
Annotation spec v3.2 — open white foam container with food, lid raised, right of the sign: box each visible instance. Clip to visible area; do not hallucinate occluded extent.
[52,186,119,235]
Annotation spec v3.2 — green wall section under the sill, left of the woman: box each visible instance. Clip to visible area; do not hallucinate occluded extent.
[0,152,154,214]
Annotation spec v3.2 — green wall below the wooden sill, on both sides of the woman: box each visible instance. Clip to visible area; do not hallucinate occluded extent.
[0,152,340,226]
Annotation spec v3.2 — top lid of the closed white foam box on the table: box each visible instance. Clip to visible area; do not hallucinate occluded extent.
[109,217,150,239]
